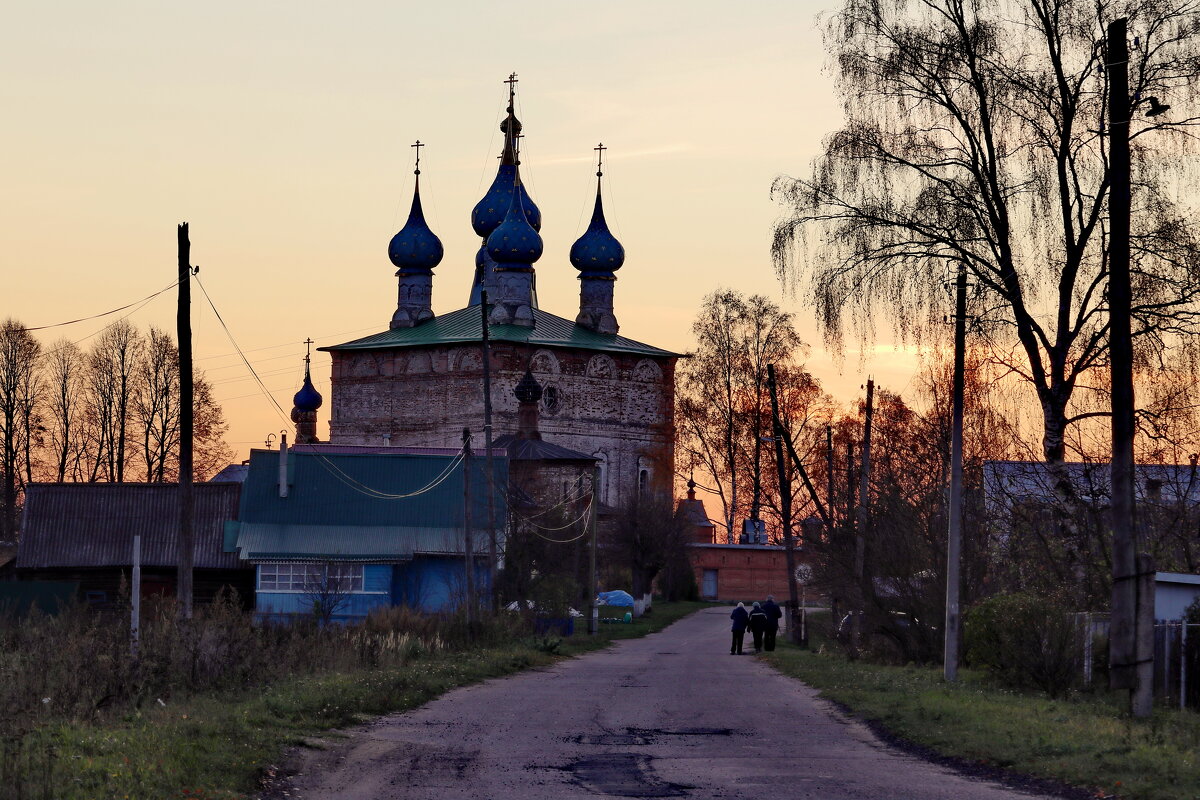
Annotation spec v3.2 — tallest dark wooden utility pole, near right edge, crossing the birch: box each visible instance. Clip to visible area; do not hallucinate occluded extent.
[1104,18,1154,717]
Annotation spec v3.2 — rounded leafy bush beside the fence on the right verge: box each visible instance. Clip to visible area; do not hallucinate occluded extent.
[962,593,1082,697]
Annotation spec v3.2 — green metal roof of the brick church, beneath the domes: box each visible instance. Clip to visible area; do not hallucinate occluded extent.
[317,306,679,357]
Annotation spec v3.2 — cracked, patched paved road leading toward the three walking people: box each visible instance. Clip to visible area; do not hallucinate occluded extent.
[276,608,1060,800]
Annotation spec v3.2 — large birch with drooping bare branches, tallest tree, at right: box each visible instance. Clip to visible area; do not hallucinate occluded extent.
[772,0,1200,463]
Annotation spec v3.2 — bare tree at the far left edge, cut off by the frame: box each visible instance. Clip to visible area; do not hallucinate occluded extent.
[0,319,41,541]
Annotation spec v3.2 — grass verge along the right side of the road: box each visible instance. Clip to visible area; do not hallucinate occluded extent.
[761,624,1200,800]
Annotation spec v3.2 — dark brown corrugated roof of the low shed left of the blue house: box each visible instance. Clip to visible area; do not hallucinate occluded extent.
[17,483,245,570]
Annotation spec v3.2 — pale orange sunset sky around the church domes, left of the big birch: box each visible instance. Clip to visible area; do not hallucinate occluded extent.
[0,0,913,457]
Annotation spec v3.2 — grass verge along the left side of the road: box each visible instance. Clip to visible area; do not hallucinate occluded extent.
[14,602,707,800]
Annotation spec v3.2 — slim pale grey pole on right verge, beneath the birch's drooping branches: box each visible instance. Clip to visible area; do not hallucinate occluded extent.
[942,261,967,681]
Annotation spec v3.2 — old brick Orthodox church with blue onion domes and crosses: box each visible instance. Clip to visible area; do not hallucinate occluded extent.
[292,79,679,509]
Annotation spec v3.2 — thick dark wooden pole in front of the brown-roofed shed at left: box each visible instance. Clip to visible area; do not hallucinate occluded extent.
[175,222,196,620]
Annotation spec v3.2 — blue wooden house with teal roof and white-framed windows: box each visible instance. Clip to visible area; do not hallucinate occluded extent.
[226,445,508,622]
